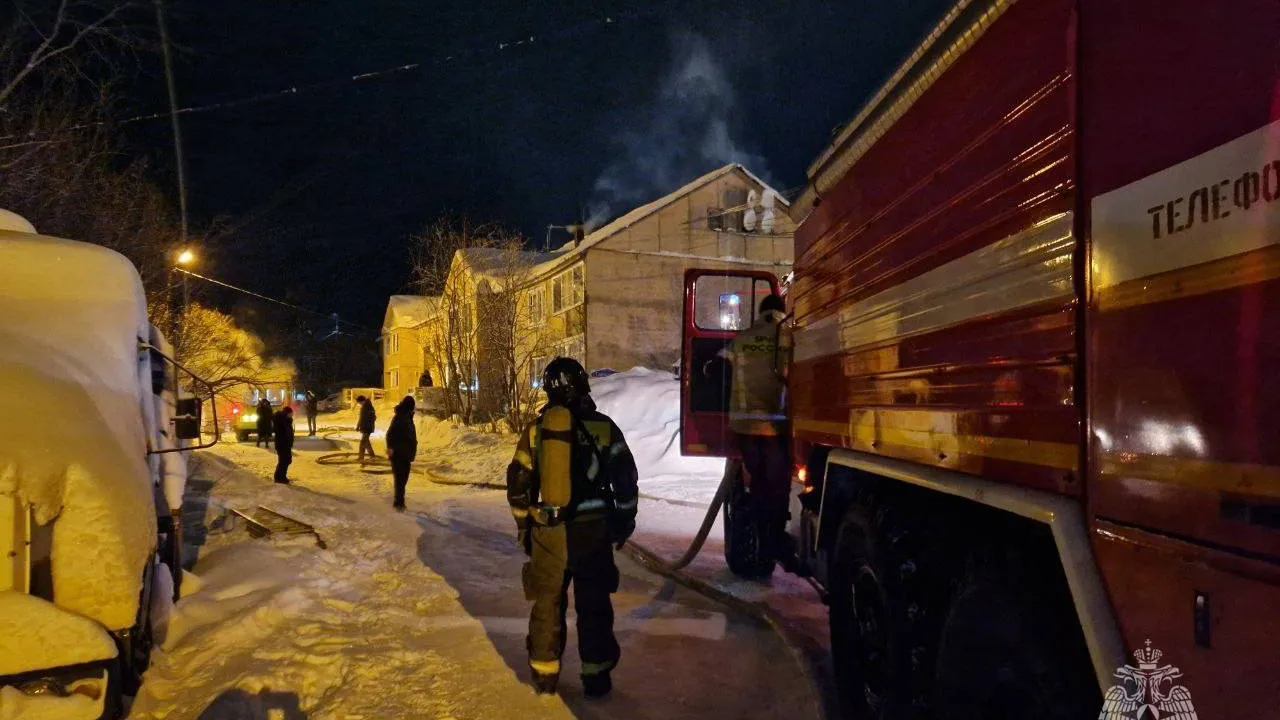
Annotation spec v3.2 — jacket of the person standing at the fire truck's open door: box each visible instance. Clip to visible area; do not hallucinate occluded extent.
[726,310,791,436]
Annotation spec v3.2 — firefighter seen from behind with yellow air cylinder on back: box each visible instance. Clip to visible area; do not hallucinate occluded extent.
[507,357,637,697]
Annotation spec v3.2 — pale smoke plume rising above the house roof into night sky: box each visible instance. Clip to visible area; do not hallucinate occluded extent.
[586,32,764,231]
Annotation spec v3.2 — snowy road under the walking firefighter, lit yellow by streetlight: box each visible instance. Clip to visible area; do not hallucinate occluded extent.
[131,438,819,720]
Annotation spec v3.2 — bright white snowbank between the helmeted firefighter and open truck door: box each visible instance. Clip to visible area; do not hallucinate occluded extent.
[591,368,724,502]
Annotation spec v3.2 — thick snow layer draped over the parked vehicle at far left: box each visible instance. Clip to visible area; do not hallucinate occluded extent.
[0,225,156,629]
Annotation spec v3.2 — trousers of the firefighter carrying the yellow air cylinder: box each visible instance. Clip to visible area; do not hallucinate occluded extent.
[522,520,621,676]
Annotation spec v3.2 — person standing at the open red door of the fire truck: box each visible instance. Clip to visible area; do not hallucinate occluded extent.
[726,293,795,568]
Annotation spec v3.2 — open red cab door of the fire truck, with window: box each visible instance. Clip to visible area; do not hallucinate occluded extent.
[680,270,778,457]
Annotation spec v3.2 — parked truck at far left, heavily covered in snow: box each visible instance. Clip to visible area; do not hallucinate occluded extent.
[0,210,212,720]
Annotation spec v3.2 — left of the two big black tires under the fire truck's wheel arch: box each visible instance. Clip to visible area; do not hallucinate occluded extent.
[829,496,946,720]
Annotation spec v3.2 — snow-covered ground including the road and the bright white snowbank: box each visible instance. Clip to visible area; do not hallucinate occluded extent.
[131,369,826,720]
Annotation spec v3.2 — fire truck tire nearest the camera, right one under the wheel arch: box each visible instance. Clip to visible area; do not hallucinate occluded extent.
[934,548,1102,720]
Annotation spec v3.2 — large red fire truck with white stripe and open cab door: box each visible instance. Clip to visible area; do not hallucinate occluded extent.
[682,0,1280,719]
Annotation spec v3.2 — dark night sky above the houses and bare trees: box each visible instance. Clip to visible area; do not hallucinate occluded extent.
[128,0,951,327]
